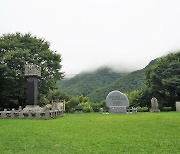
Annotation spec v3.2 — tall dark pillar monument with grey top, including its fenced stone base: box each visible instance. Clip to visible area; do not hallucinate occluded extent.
[0,64,64,119]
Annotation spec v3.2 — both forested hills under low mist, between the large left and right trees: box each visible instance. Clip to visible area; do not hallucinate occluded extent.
[58,60,154,102]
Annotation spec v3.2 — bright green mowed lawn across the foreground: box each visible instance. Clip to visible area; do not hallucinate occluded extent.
[0,112,180,154]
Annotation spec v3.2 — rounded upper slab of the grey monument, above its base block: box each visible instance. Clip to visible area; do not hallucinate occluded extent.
[106,90,129,107]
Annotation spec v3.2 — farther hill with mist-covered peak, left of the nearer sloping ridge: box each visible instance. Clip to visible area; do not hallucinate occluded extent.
[58,67,126,96]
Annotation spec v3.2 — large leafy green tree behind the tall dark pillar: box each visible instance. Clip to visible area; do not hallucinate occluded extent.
[0,33,63,107]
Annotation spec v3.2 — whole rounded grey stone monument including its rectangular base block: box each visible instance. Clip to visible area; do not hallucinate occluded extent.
[106,90,129,113]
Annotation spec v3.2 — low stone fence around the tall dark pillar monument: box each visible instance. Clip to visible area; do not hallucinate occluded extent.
[0,110,64,119]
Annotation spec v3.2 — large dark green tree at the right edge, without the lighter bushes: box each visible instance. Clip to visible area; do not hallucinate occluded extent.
[146,52,180,107]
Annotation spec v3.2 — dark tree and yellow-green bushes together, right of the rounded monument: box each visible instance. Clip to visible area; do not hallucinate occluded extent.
[128,52,180,111]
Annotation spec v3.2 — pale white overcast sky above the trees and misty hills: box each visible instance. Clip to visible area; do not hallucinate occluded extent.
[0,0,180,74]
